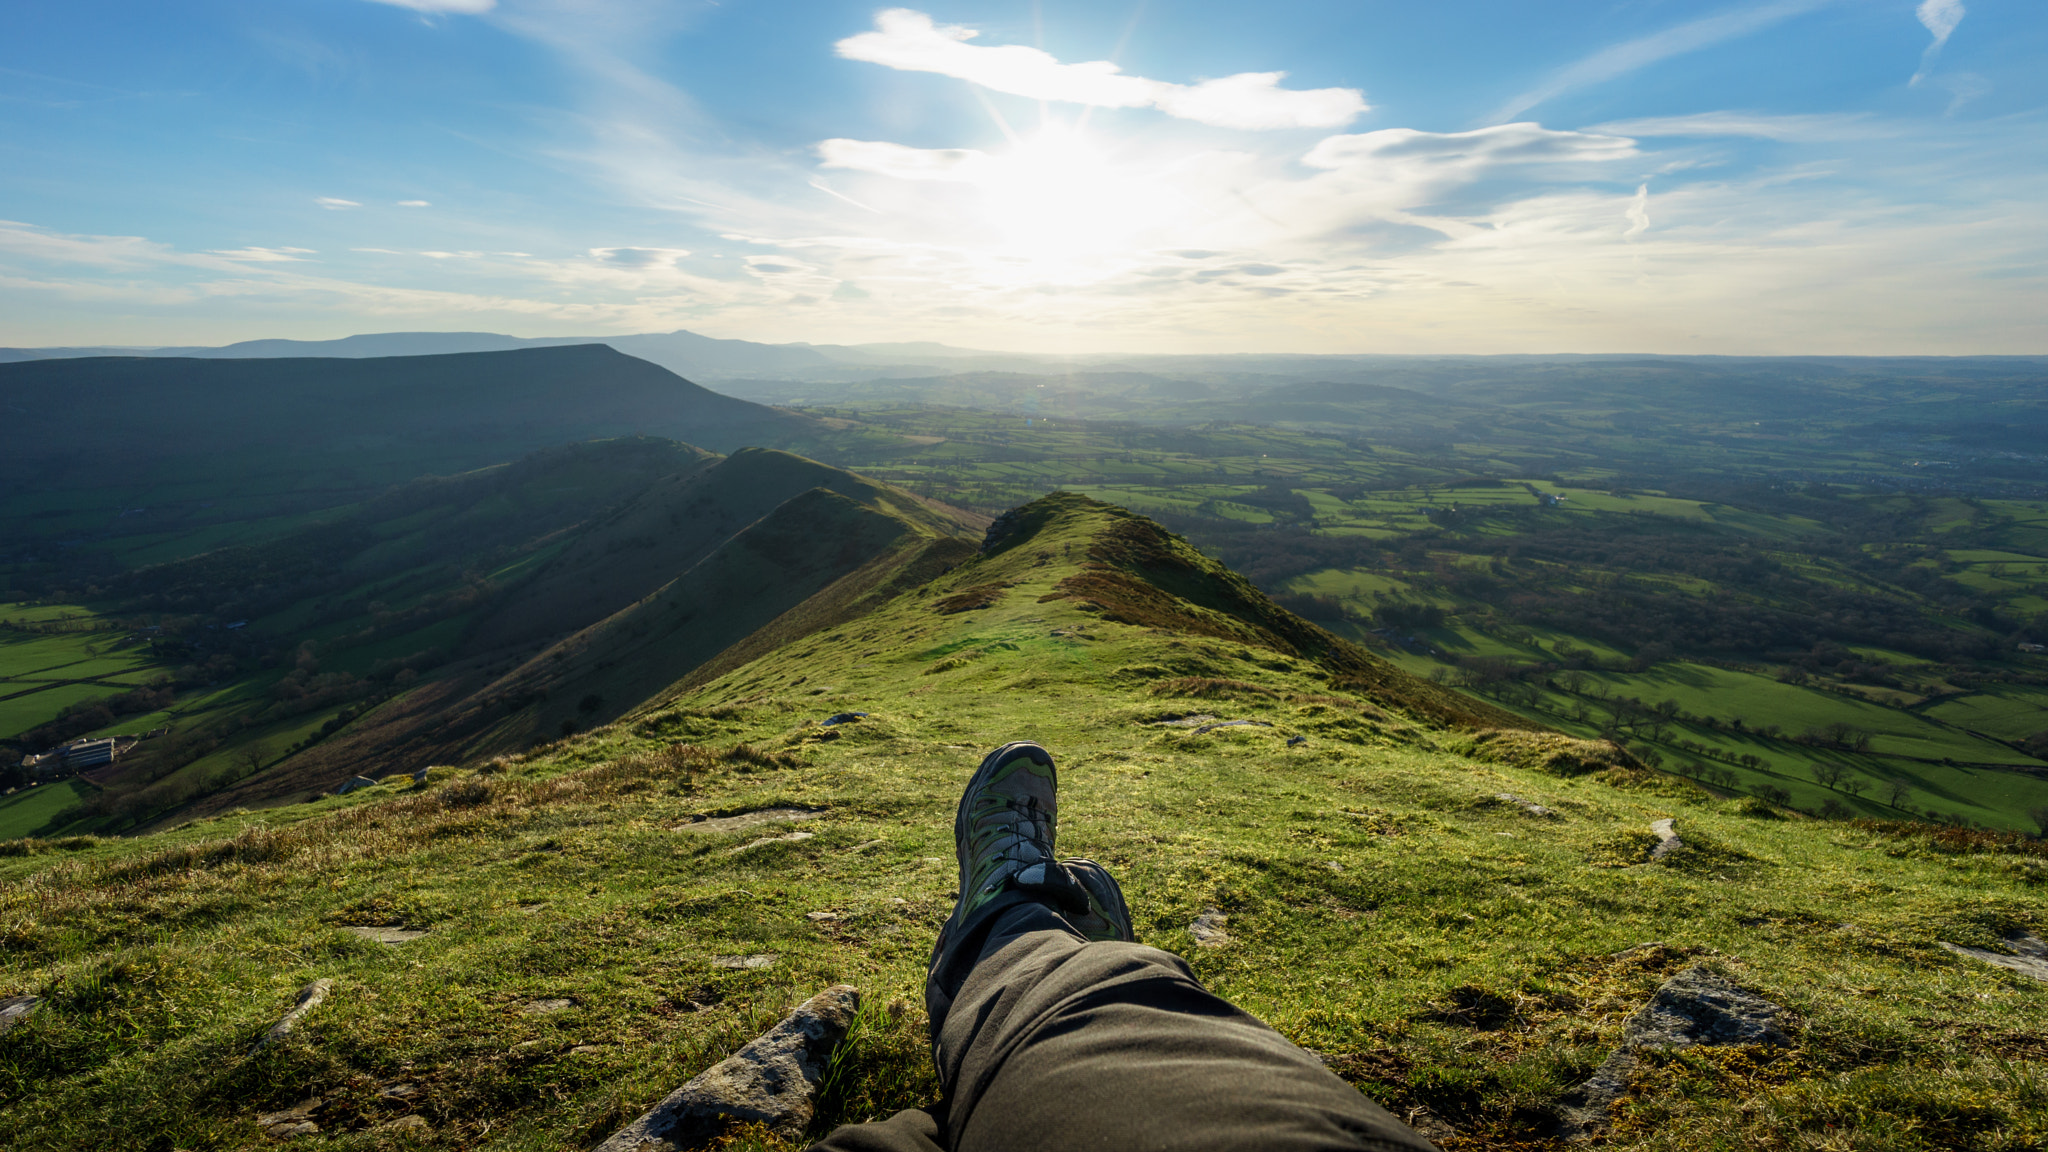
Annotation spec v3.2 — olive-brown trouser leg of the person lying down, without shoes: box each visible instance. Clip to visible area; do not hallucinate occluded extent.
[817,904,1434,1152]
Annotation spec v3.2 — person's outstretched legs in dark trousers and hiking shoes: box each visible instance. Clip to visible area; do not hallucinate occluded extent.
[819,744,1434,1152]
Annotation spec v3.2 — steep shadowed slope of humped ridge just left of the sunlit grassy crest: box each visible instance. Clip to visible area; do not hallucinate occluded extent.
[161,449,979,814]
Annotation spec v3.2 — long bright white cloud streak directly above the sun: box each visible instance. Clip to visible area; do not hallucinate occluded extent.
[834,8,1368,129]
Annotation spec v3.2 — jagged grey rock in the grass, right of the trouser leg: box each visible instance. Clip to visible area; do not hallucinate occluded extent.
[1559,963,1790,1140]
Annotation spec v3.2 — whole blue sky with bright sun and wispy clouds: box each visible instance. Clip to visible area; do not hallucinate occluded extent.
[0,0,2048,353]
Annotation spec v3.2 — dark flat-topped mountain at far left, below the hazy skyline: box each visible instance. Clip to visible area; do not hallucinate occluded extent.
[0,344,813,486]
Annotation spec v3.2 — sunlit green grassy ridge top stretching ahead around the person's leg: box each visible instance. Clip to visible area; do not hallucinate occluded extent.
[0,487,2048,1150]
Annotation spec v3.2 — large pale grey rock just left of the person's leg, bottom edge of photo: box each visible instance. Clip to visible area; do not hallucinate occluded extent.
[596,984,860,1152]
